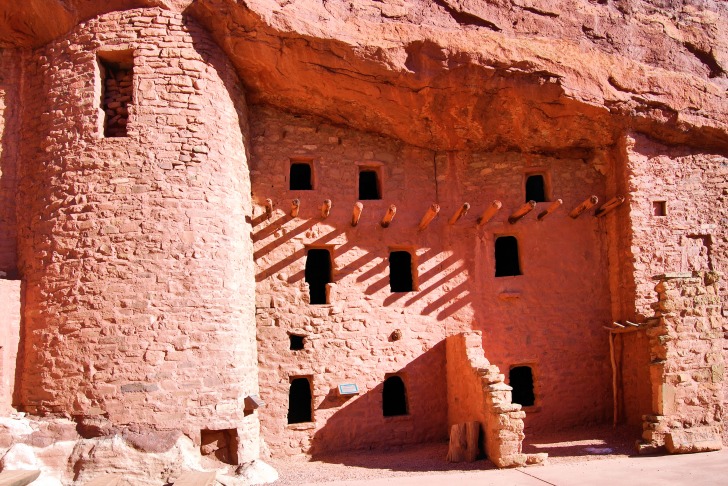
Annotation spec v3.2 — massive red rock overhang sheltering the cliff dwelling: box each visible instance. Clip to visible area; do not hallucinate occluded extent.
[0,0,728,154]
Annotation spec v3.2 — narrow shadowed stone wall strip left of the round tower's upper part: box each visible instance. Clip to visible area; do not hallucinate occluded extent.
[0,49,20,278]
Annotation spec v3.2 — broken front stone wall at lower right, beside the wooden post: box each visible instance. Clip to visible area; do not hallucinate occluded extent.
[641,272,725,453]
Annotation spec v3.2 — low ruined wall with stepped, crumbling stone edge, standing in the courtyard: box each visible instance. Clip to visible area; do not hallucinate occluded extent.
[446,331,546,467]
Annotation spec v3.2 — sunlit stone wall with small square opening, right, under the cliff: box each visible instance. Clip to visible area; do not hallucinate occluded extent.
[615,134,728,438]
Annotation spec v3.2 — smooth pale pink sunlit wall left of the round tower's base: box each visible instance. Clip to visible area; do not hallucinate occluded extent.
[0,279,20,417]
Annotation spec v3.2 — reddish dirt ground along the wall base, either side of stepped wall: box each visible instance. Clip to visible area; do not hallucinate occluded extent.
[266,426,639,486]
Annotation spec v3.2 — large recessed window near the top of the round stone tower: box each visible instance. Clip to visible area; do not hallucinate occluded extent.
[98,50,134,137]
